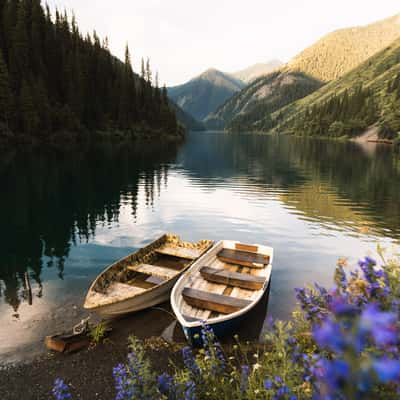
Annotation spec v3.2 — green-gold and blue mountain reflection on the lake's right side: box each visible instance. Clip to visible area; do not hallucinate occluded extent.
[181,134,400,238]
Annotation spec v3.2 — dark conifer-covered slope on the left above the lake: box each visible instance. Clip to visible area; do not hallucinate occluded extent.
[0,0,180,139]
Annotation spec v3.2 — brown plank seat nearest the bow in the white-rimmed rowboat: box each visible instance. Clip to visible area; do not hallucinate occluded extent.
[182,288,251,314]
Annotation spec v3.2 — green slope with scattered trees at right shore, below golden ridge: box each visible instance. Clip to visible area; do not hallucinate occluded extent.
[272,38,400,139]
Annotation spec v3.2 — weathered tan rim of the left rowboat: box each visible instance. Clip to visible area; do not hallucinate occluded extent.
[83,233,215,311]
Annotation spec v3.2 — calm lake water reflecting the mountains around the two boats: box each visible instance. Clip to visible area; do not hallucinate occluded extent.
[0,132,400,362]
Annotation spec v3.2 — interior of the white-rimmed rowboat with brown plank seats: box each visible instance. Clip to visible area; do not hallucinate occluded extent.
[178,243,271,322]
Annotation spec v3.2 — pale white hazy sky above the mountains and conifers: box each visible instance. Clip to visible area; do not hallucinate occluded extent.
[45,0,400,85]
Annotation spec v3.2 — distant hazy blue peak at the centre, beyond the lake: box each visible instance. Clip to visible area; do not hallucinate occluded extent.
[168,69,245,120]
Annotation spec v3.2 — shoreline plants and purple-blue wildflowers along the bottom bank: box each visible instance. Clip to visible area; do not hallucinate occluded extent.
[0,246,400,400]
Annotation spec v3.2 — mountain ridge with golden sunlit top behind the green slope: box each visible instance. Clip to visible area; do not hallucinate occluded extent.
[205,15,400,130]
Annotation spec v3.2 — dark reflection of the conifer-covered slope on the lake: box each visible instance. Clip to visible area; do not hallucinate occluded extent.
[0,143,177,311]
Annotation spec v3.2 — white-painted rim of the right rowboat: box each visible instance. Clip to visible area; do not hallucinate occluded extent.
[171,240,274,329]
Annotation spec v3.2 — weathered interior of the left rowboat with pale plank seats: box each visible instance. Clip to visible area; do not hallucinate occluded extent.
[86,235,213,307]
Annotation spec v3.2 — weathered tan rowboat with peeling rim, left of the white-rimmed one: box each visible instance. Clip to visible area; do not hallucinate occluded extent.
[84,234,213,317]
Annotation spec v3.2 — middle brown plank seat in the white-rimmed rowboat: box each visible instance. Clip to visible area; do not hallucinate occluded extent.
[200,267,265,290]
